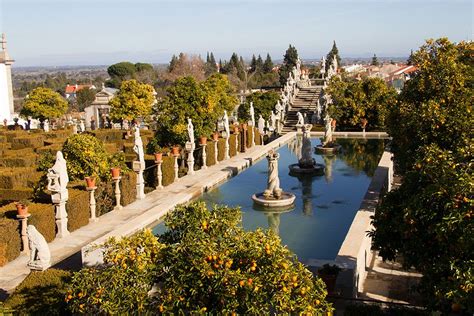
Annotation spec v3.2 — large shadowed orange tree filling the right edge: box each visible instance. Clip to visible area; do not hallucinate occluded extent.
[371,38,474,313]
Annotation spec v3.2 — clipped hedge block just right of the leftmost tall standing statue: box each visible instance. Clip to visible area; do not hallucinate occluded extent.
[66,189,91,232]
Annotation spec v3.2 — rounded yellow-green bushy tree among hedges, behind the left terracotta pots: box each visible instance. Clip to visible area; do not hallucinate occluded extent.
[63,134,110,180]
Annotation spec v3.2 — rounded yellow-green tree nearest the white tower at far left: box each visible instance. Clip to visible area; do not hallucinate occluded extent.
[20,87,68,122]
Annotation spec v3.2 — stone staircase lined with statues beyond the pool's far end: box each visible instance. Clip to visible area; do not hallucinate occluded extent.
[282,85,322,134]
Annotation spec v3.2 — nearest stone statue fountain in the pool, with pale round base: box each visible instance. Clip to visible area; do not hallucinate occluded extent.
[252,150,296,208]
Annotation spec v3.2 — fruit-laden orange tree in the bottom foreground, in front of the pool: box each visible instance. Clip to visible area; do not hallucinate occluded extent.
[66,202,332,315]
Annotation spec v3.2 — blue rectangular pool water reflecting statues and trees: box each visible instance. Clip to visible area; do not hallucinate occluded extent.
[154,137,384,263]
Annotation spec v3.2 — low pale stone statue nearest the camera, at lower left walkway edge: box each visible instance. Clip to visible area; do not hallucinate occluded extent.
[26,225,51,271]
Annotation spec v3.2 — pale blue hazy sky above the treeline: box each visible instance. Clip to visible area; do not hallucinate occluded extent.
[0,0,474,67]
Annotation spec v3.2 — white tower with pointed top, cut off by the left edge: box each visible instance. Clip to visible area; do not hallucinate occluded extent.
[0,34,14,124]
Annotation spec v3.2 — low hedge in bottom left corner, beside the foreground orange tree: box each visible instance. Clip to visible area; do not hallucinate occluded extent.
[5,269,72,315]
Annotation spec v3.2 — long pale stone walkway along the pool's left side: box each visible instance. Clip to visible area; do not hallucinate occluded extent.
[0,133,295,293]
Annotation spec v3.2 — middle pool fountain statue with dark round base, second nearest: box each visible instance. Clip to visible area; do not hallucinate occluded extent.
[288,124,324,175]
